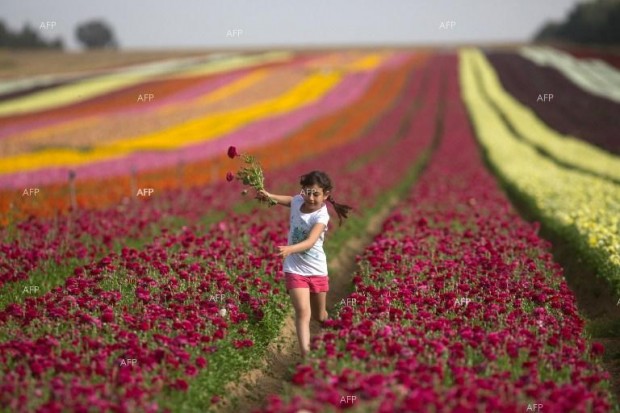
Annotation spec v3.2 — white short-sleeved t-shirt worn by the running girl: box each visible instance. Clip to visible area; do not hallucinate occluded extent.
[284,195,329,276]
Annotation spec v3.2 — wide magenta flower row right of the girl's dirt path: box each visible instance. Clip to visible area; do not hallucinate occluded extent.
[262,56,611,413]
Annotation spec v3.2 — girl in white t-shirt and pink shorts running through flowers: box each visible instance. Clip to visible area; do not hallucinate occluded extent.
[257,171,352,360]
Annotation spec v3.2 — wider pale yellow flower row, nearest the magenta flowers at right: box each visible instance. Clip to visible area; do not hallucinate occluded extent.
[459,49,620,291]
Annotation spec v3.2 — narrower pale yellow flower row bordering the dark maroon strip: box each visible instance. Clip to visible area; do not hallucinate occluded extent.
[468,50,620,182]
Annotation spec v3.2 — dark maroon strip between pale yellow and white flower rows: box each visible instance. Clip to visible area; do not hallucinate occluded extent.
[486,52,620,155]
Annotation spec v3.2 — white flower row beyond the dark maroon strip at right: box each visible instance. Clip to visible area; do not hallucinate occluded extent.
[520,46,620,102]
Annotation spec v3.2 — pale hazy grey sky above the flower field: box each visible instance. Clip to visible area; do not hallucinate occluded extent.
[0,0,580,50]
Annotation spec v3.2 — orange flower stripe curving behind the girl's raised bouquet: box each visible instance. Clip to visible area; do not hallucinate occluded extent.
[0,53,428,225]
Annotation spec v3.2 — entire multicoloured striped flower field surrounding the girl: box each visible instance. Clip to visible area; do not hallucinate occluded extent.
[0,45,620,412]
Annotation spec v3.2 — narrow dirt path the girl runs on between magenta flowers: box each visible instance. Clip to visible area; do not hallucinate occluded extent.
[215,196,398,413]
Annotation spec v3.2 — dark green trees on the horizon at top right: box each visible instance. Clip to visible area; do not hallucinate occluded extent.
[534,0,620,45]
